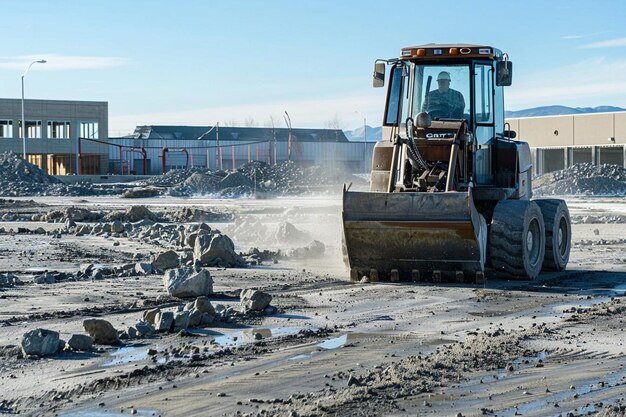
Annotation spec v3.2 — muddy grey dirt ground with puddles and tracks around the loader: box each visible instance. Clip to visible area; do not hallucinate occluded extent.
[0,197,626,417]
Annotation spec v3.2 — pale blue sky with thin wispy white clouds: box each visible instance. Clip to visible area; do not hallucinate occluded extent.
[0,0,626,135]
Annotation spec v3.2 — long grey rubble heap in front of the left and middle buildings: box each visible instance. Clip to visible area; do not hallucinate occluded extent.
[0,152,363,198]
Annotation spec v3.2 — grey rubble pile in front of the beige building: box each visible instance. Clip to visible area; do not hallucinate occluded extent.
[533,163,626,197]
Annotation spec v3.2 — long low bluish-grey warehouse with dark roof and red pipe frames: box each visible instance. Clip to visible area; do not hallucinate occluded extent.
[109,125,374,175]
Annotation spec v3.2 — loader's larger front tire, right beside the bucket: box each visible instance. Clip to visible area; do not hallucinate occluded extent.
[489,200,545,279]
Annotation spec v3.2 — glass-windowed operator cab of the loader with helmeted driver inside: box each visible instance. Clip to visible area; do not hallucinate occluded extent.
[375,45,517,191]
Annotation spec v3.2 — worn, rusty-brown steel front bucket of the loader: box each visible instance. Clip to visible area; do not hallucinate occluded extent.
[343,190,487,281]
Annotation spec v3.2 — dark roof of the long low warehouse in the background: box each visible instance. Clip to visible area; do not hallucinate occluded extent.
[132,125,348,142]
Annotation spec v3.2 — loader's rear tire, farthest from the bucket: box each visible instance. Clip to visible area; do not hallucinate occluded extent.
[533,198,572,271]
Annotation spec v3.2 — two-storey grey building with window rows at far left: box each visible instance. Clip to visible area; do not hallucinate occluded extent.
[0,99,109,175]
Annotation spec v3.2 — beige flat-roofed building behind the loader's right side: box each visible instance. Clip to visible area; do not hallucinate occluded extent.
[506,112,626,175]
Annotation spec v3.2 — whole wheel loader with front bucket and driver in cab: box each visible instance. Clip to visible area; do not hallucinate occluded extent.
[343,44,571,283]
